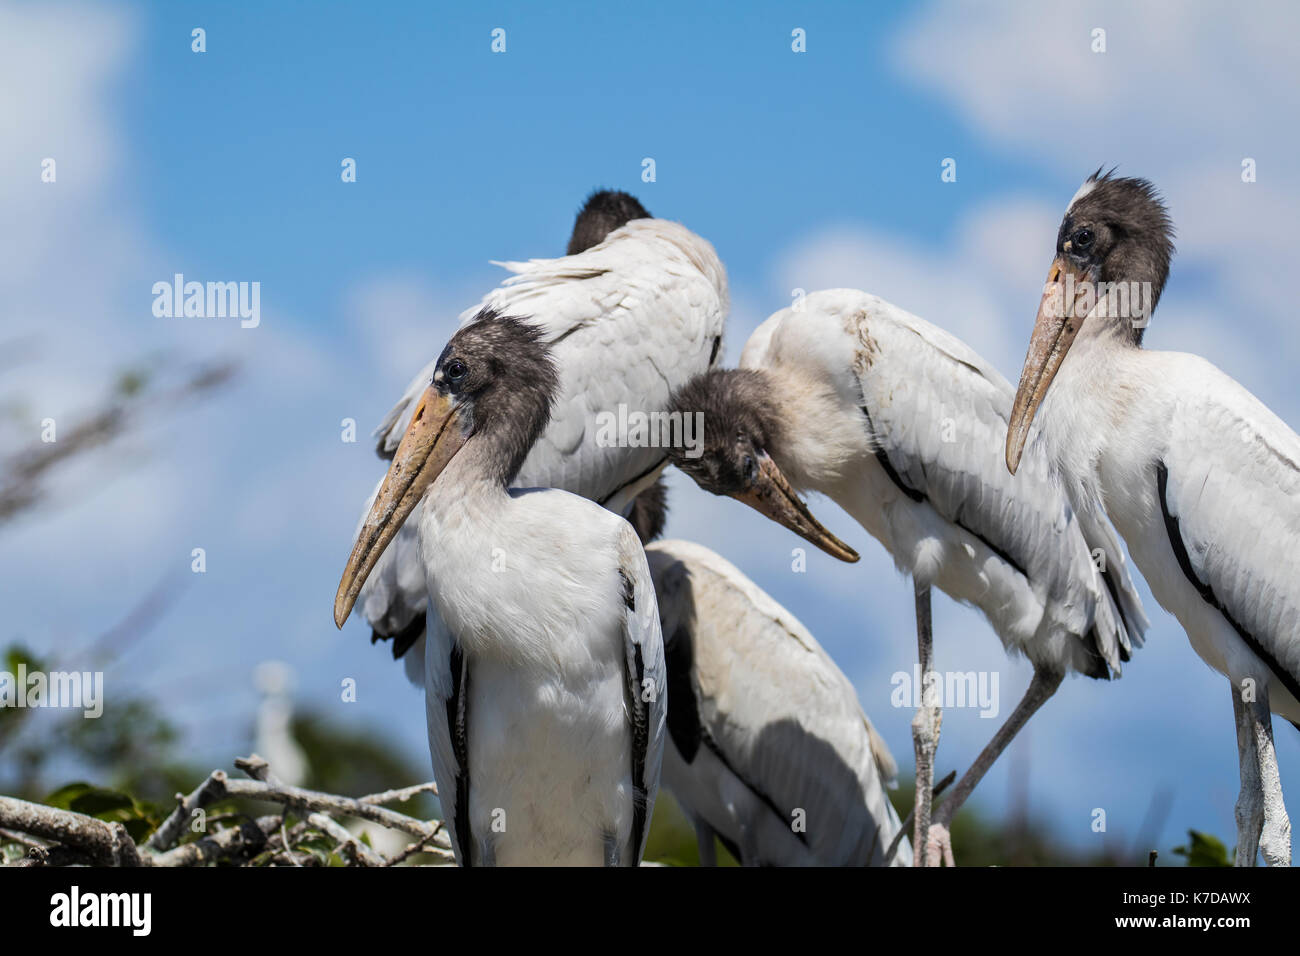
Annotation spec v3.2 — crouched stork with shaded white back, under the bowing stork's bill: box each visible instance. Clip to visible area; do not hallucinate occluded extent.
[646,541,911,866]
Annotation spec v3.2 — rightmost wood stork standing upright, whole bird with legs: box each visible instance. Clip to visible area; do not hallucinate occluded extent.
[1006,169,1300,865]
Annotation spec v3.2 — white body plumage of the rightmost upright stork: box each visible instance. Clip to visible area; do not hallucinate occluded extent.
[1039,343,1300,721]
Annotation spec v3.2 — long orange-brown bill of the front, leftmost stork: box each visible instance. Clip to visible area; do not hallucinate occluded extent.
[334,386,467,627]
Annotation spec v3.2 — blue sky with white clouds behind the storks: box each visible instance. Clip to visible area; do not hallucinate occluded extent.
[0,3,1300,863]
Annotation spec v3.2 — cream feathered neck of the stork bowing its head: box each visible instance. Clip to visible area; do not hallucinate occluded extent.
[763,365,863,494]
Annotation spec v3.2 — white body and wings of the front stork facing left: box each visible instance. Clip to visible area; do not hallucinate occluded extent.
[420,481,667,866]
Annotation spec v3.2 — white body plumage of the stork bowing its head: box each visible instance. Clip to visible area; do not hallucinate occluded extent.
[741,289,1147,676]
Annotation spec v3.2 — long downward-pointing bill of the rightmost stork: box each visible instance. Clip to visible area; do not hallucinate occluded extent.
[1006,256,1089,475]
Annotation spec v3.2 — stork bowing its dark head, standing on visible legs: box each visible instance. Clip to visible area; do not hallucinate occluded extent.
[673,289,1147,865]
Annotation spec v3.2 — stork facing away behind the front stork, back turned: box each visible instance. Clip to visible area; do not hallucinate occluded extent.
[359,190,728,683]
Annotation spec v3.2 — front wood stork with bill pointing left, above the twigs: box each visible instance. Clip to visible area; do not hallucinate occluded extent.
[334,310,666,866]
